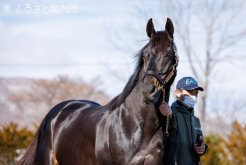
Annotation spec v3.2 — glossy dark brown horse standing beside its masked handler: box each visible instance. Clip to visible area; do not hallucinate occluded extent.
[19,18,178,165]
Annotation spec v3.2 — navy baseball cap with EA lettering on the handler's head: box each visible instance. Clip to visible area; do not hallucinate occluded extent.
[176,77,203,91]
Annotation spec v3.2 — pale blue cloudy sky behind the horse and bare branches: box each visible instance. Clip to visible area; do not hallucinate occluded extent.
[0,0,246,122]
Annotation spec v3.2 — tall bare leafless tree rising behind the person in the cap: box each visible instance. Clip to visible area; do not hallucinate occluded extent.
[107,0,246,122]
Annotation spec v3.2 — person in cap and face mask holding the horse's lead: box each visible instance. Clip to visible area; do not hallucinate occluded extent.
[160,77,207,165]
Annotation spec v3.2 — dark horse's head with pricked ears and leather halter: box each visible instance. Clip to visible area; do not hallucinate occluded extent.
[142,18,178,103]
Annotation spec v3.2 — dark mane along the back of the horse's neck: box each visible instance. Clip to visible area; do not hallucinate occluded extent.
[106,43,149,110]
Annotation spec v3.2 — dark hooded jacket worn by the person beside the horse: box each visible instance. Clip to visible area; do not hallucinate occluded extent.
[164,100,206,165]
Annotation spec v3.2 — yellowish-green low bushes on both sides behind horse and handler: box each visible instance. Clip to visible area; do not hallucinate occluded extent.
[0,121,246,165]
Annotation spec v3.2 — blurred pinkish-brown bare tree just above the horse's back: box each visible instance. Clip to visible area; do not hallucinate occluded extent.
[9,76,109,126]
